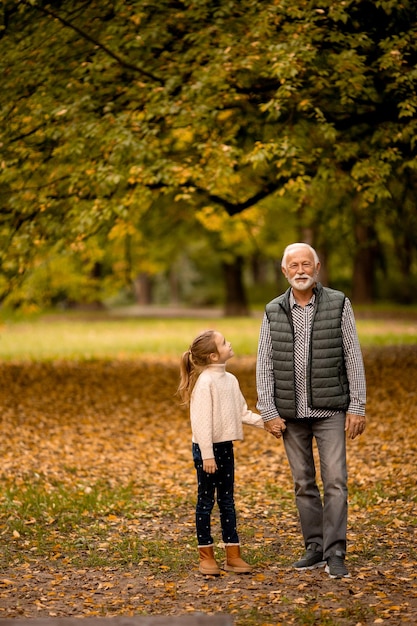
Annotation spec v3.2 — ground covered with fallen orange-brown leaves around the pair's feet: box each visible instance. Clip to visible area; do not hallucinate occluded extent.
[0,346,417,626]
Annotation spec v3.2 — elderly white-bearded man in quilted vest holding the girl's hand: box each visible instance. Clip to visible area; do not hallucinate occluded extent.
[256,243,366,578]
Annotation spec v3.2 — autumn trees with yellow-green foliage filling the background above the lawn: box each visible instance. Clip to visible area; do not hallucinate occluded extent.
[0,0,417,315]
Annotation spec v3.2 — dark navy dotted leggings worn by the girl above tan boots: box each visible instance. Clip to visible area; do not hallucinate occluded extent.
[193,441,239,546]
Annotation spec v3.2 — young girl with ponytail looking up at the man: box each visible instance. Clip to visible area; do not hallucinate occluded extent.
[178,330,264,575]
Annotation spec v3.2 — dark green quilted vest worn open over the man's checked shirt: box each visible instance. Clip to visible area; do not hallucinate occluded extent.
[266,283,349,419]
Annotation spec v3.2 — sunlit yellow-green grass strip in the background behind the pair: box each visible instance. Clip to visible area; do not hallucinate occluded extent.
[0,316,417,361]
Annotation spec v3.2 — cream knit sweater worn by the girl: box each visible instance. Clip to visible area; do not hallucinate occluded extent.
[190,364,264,459]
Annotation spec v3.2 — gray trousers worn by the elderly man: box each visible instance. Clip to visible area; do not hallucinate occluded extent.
[284,413,347,559]
